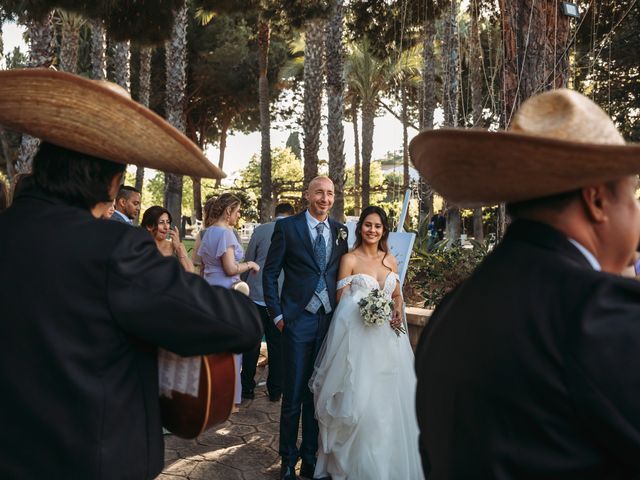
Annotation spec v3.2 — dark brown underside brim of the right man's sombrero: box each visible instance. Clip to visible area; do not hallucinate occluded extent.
[409,129,640,207]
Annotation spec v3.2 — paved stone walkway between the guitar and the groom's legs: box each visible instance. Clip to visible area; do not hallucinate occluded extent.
[157,369,280,480]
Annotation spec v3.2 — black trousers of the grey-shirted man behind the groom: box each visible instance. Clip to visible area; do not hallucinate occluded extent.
[240,305,283,395]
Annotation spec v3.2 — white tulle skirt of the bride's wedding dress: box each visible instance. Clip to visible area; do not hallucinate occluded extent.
[310,290,424,480]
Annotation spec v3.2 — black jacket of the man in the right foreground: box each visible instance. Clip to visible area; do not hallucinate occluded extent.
[416,221,640,480]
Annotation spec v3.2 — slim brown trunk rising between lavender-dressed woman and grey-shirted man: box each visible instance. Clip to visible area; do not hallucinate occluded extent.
[258,17,273,223]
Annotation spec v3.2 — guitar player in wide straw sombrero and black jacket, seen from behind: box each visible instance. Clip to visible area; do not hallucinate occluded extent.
[0,68,262,480]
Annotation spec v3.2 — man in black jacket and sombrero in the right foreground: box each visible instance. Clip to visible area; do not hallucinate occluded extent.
[411,90,640,480]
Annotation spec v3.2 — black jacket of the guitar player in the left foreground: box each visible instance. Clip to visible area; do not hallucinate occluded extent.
[0,188,262,480]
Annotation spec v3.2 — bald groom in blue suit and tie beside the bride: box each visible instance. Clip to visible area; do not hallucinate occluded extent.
[262,177,347,480]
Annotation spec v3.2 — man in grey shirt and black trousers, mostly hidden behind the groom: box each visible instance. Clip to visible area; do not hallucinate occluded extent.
[242,203,295,402]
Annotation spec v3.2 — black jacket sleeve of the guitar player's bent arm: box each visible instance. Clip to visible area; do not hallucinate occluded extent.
[107,228,262,356]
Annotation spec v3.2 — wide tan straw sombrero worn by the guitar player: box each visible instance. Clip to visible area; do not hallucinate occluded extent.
[0,68,225,178]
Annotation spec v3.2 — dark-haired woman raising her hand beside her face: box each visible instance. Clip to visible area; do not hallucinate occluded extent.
[140,205,195,273]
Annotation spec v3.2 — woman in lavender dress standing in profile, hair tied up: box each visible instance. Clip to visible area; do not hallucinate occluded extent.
[198,193,260,411]
